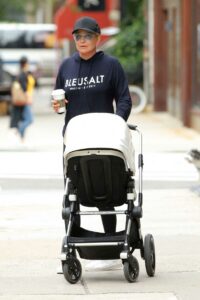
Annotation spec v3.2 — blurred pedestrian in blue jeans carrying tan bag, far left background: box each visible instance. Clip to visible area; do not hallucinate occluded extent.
[10,57,35,141]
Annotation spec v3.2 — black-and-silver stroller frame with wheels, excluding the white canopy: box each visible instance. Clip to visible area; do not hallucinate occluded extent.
[61,125,156,284]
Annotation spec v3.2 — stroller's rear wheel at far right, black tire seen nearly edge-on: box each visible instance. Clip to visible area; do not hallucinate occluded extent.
[144,234,156,277]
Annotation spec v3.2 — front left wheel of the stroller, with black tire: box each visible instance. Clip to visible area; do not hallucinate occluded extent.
[63,257,82,284]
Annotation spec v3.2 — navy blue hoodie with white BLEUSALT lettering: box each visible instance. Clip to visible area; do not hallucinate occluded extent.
[55,51,132,134]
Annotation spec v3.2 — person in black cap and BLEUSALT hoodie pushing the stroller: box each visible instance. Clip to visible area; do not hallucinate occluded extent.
[52,17,132,270]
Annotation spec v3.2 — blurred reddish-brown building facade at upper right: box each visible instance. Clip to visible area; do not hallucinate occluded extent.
[146,0,200,131]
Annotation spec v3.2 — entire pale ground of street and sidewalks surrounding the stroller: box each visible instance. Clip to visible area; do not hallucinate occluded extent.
[0,85,200,300]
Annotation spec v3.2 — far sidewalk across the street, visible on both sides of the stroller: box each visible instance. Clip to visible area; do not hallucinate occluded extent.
[0,110,200,152]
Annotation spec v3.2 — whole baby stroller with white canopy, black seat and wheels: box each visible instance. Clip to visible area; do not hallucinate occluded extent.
[61,113,155,284]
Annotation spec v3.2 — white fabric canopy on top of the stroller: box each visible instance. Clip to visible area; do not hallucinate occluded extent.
[64,113,135,172]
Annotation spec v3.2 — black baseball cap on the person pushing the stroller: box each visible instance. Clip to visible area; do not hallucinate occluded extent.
[72,17,101,34]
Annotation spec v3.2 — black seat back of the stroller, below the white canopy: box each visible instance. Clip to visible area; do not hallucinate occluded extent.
[67,151,128,208]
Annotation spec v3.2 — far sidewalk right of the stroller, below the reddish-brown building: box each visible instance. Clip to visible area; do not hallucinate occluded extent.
[129,112,200,152]
